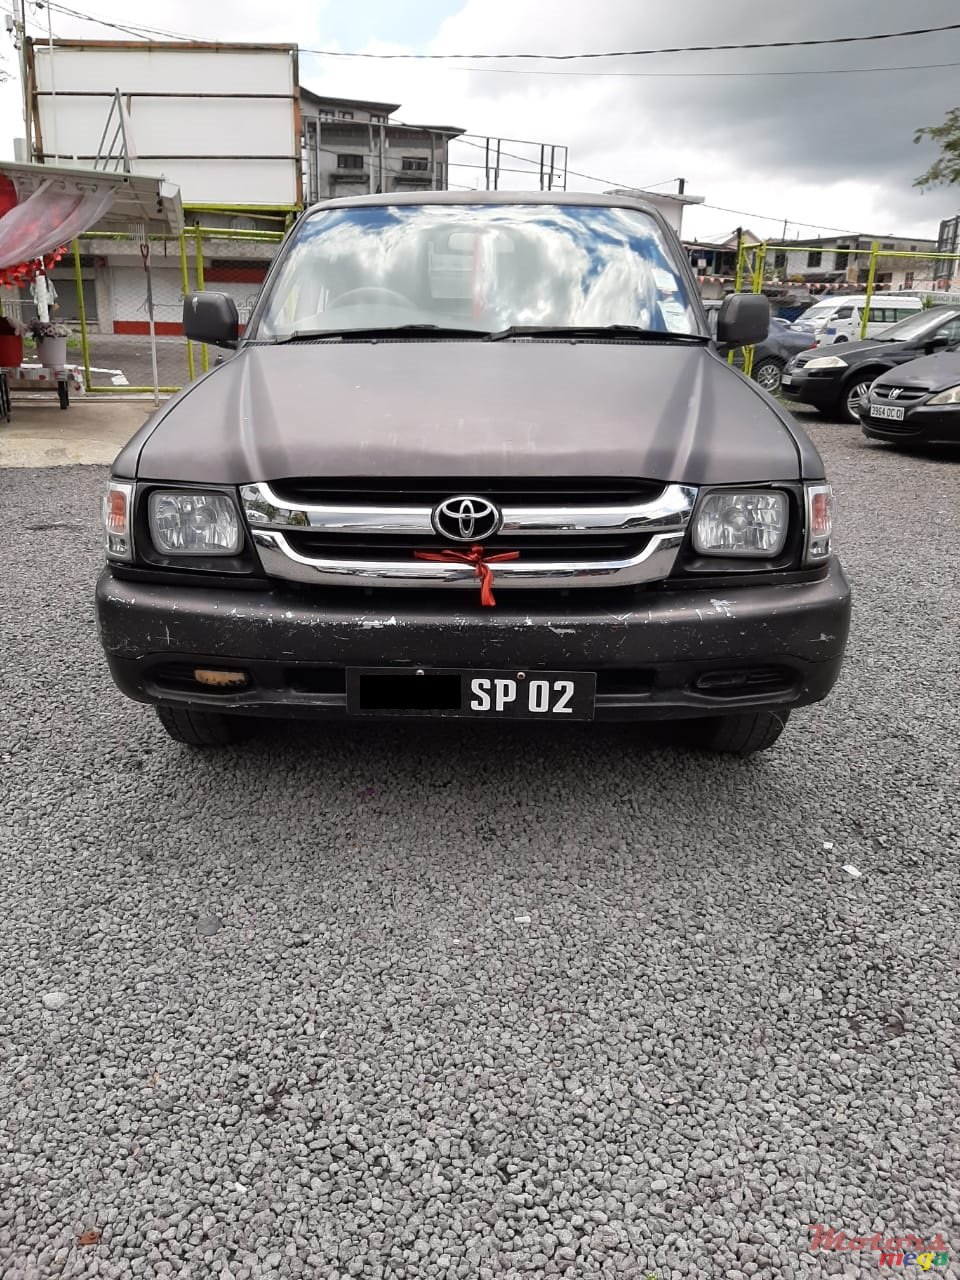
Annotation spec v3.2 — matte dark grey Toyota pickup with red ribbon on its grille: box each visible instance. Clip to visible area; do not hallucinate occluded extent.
[97,192,850,755]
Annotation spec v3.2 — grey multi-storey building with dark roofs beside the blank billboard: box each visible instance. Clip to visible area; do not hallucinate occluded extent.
[300,86,463,205]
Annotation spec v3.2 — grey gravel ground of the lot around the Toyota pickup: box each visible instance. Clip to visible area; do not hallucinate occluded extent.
[0,414,960,1280]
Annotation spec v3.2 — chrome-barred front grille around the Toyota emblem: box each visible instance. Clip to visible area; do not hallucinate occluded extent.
[241,477,696,590]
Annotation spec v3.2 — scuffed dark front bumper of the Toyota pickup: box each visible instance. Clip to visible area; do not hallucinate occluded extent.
[97,561,850,719]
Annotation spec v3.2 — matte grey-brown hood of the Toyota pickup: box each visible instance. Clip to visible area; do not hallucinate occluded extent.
[129,339,823,485]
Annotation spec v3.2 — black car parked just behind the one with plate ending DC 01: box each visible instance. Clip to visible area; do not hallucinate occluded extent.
[781,307,960,422]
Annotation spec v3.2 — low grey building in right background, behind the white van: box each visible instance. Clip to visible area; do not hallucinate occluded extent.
[783,236,937,291]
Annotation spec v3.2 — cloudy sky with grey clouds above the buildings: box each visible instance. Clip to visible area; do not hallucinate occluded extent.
[0,0,960,237]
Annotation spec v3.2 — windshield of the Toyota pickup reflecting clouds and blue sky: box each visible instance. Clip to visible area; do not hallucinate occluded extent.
[248,204,703,339]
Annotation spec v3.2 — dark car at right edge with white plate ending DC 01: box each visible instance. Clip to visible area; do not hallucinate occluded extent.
[860,351,960,444]
